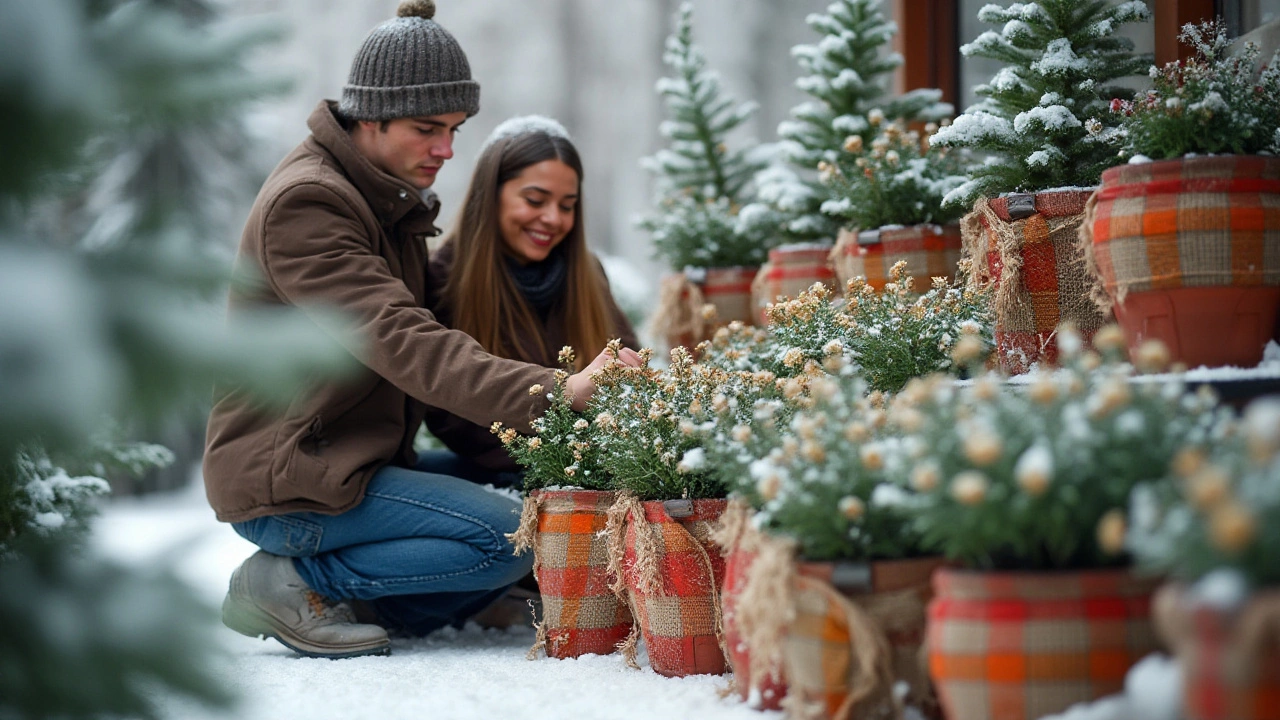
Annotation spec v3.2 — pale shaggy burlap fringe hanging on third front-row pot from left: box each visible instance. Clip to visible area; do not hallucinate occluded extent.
[733,527,796,688]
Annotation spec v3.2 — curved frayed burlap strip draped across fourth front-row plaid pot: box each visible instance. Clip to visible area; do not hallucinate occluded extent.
[782,575,902,720]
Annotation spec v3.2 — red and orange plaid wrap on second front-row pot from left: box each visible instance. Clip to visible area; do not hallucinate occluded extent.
[622,500,727,676]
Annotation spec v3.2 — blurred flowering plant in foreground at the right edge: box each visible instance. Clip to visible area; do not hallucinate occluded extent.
[1126,398,1280,588]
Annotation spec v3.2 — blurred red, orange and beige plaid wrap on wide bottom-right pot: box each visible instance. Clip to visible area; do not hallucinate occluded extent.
[927,569,1158,720]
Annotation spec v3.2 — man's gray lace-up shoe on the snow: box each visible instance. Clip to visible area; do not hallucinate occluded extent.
[223,550,390,659]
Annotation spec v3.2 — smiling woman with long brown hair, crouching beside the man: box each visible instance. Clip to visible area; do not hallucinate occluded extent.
[426,115,637,486]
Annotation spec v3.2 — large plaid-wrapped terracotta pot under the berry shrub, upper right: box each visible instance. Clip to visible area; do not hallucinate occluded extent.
[1082,155,1280,366]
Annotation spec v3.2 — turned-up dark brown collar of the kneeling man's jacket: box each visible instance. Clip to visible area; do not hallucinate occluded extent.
[307,100,440,229]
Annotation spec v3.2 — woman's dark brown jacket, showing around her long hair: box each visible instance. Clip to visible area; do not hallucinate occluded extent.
[426,243,640,471]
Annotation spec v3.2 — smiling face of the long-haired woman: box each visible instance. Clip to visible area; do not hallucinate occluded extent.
[498,160,579,263]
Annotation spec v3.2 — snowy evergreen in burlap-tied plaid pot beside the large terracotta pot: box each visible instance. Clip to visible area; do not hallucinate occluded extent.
[931,0,1151,373]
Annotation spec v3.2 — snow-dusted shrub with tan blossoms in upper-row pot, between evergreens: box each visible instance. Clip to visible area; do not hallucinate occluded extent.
[819,117,965,229]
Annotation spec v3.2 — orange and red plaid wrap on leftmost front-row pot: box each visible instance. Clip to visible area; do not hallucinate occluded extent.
[534,489,631,657]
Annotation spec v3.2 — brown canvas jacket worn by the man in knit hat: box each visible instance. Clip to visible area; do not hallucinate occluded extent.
[204,101,553,523]
